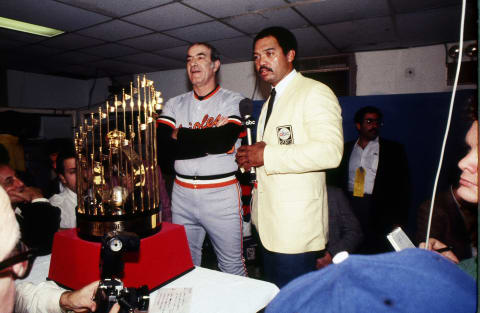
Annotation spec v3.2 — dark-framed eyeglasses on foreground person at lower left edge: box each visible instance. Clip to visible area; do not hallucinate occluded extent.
[0,241,37,279]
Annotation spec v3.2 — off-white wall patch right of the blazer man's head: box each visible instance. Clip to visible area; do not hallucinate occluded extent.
[355,45,476,96]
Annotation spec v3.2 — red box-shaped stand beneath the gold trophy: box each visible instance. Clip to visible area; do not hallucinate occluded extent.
[48,222,194,291]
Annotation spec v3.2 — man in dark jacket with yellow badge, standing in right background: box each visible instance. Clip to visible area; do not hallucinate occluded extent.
[337,106,410,254]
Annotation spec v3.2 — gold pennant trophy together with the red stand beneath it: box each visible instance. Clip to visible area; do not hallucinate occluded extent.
[48,76,194,296]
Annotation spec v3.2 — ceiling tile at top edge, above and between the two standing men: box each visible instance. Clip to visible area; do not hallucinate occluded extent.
[182,0,286,18]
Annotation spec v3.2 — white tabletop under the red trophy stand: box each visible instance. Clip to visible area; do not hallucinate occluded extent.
[22,255,279,313]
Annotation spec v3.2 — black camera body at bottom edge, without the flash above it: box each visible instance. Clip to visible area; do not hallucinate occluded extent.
[95,278,150,313]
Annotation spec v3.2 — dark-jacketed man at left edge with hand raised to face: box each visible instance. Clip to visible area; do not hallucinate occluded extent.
[0,164,60,255]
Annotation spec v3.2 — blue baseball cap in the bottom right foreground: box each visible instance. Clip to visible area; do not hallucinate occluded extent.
[266,248,477,313]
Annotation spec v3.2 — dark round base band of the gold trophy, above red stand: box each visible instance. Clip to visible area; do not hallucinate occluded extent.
[77,210,162,241]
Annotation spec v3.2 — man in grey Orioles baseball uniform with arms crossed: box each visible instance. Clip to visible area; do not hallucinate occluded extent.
[157,43,246,275]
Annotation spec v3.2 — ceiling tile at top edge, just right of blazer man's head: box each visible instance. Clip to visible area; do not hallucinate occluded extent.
[296,0,390,25]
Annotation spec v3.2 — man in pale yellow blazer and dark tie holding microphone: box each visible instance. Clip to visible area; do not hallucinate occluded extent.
[237,27,343,287]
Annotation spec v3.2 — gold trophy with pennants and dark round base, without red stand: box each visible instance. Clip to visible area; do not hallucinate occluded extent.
[75,76,163,240]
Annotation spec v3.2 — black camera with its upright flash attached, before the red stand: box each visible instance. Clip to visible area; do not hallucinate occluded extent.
[95,232,150,313]
